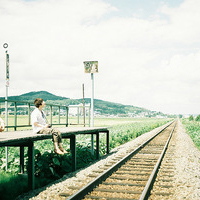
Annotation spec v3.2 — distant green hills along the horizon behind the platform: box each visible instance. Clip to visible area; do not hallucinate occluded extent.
[0,91,172,117]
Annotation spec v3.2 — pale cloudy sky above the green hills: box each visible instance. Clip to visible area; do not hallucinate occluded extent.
[0,0,200,114]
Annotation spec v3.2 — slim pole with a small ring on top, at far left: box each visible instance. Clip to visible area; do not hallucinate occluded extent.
[3,43,10,171]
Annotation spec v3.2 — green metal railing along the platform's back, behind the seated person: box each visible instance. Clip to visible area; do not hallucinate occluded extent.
[0,99,90,131]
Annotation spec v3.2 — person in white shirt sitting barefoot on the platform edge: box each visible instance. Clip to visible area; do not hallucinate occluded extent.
[31,98,67,155]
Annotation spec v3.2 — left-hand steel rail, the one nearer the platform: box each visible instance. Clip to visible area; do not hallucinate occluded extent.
[67,121,174,200]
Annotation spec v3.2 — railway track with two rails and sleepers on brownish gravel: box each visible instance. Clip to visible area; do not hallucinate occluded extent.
[60,122,176,200]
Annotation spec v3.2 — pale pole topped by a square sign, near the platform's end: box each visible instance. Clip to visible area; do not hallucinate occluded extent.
[83,61,98,155]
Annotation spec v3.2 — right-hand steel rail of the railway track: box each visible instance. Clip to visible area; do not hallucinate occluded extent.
[139,119,177,200]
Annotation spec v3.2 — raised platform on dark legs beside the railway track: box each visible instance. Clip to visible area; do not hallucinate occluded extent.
[0,127,109,189]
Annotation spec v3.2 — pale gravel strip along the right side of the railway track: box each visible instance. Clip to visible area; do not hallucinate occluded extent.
[174,119,200,200]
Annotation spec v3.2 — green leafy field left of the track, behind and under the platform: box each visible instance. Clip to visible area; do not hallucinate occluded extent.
[0,116,170,199]
